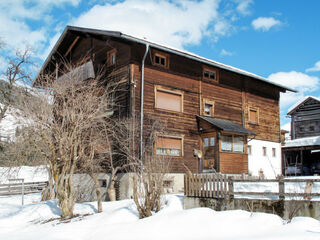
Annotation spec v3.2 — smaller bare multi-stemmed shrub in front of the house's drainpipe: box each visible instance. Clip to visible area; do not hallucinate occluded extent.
[117,115,170,218]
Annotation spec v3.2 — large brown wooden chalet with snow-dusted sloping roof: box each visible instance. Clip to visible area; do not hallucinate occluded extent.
[39,26,294,176]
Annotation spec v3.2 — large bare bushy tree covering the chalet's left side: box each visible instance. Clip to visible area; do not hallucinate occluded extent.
[16,61,119,218]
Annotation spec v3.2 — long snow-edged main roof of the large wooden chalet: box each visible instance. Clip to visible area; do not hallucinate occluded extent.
[36,26,296,92]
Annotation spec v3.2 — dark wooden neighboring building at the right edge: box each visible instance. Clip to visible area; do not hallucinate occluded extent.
[282,96,320,175]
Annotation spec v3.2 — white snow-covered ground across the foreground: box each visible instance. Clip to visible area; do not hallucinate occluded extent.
[0,194,320,240]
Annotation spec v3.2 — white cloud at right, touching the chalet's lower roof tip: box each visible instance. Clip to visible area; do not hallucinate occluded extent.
[268,71,320,109]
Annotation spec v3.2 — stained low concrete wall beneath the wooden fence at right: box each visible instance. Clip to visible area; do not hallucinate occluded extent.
[184,197,320,220]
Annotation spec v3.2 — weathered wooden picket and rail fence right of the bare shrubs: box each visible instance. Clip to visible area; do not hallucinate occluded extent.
[184,174,320,199]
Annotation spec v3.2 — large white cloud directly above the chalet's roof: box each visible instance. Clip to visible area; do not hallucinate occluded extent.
[71,0,230,48]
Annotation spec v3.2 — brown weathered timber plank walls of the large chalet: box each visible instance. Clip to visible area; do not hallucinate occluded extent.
[37,27,287,173]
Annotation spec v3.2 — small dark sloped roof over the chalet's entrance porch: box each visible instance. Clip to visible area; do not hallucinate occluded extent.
[197,116,257,136]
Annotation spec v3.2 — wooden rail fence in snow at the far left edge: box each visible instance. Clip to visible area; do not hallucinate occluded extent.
[0,182,48,196]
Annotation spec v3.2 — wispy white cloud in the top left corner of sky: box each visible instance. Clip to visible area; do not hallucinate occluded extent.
[0,0,81,53]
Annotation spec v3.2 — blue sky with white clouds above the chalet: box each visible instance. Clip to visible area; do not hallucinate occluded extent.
[0,0,320,129]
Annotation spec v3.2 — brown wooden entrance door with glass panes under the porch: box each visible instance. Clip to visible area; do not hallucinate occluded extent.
[202,133,217,170]
